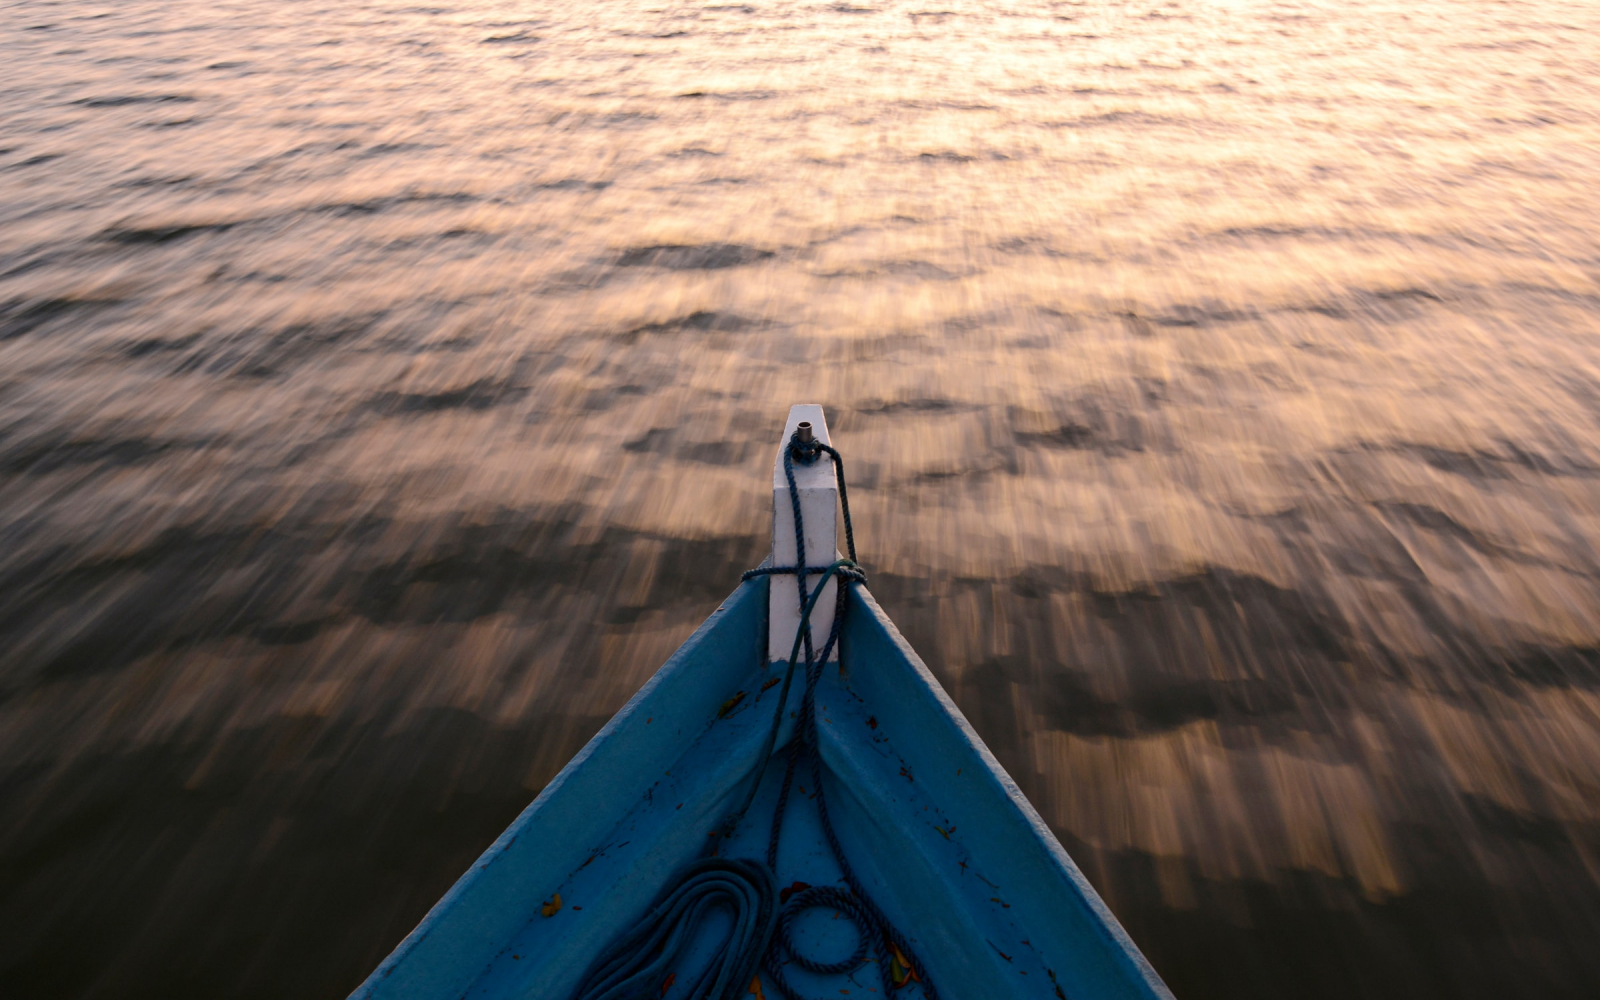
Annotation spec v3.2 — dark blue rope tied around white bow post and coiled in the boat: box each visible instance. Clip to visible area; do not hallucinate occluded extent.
[574,430,938,1000]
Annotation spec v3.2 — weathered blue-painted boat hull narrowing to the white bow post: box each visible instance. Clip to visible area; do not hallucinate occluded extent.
[354,578,1171,1000]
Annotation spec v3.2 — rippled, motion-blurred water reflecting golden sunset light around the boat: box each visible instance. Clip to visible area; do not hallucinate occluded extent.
[0,0,1600,998]
